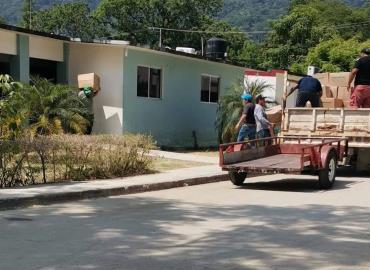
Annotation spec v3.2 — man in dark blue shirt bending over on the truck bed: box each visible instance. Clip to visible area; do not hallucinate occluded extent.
[285,76,322,108]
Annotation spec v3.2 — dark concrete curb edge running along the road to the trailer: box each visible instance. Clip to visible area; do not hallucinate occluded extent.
[0,174,228,211]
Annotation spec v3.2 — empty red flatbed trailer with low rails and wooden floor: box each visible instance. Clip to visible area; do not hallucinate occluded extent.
[219,137,348,189]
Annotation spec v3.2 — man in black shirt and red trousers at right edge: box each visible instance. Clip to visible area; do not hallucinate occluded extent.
[348,49,370,108]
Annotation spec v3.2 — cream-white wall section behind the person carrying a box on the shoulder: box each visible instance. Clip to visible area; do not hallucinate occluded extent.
[69,43,124,134]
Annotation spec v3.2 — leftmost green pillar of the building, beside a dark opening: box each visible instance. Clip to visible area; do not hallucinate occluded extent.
[11,34,30,83]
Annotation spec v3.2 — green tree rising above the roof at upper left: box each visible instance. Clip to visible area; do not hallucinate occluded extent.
[33,1,102,39]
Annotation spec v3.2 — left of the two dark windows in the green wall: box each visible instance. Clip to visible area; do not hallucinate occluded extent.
[137,66,162,98]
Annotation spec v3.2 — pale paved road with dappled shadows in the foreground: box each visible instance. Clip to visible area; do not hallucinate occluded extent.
[0,176,370,270]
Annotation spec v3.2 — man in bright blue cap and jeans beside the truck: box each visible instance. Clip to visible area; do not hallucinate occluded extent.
[235,93,256,142]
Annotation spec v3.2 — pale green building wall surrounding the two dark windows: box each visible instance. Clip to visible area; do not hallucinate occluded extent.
[123,48,244,147]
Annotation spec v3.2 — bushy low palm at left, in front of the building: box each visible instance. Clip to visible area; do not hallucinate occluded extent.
[0,78,92,138]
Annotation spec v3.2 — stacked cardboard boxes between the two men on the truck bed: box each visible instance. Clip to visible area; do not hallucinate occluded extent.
[315,72,351,108]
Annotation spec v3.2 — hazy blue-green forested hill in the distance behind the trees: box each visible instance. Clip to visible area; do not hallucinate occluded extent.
[0,0,370,31]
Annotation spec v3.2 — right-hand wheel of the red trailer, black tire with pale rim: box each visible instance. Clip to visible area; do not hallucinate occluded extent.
[319,150,338,189]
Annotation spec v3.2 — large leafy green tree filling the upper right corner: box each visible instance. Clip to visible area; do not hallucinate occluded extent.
[263,0,370,69]
